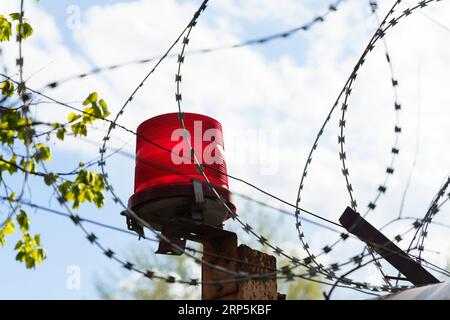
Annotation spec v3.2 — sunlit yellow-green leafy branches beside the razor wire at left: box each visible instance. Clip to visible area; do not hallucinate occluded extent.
[0,1,109,269]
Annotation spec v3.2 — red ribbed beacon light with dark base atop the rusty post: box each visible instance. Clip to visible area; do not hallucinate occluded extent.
[127,113,236,255]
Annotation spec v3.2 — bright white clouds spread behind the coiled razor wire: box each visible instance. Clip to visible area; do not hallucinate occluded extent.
[8,0,450,300]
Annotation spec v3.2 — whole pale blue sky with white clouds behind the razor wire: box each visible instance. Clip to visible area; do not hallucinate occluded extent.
[0,0,450,299]
